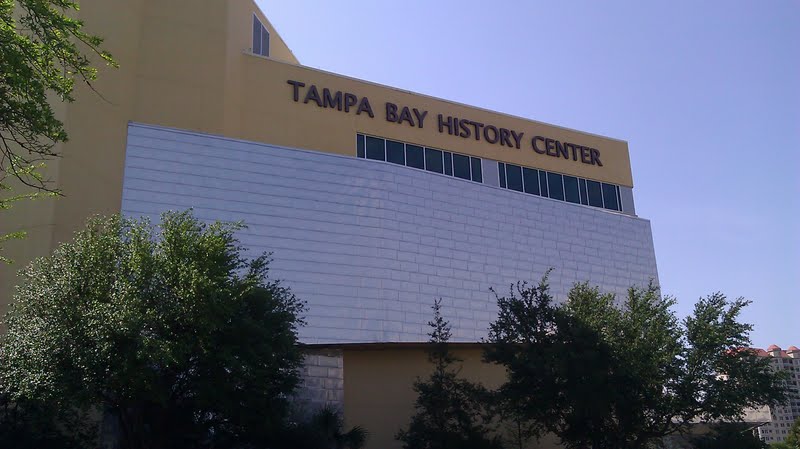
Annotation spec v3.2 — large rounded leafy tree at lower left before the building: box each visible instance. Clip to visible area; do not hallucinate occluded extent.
[0,212,304,449]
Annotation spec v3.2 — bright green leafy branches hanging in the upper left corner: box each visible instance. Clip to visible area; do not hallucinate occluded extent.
[0,0,116,262]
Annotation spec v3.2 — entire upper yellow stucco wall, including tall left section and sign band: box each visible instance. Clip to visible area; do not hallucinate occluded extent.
[0,0,632,312]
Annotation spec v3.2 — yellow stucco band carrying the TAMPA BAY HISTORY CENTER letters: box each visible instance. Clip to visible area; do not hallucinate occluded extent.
[241,55,633,187]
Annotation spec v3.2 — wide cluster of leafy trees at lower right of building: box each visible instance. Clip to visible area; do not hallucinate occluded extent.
[486,277,785,448]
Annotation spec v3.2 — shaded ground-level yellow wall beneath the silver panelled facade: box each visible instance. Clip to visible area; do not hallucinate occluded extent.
[343,345,559,449]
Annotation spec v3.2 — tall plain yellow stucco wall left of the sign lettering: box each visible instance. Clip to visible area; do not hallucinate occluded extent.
[0,0,297,313]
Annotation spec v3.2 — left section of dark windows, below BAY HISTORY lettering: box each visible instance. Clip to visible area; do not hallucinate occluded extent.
[356,134,483,182]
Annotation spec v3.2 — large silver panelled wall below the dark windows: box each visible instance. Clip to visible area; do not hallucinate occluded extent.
[122,125,657,343]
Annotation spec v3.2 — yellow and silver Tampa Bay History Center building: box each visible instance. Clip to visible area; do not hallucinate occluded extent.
[0,0,658,448]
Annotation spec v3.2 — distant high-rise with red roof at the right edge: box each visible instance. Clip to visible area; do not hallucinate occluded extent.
[753,345,800,443]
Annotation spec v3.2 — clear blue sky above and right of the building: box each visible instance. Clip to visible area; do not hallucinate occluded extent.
[258,0,800,348]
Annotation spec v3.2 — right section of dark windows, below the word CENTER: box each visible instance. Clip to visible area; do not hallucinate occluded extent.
[497,162,622,211]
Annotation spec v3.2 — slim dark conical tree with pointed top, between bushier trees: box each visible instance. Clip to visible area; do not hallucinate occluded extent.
[396,300,502,449]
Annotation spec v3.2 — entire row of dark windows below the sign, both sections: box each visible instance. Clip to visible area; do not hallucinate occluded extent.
[356,134,622,211]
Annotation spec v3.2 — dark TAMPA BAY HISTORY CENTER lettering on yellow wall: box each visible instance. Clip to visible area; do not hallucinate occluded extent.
[286,80,603,167]
